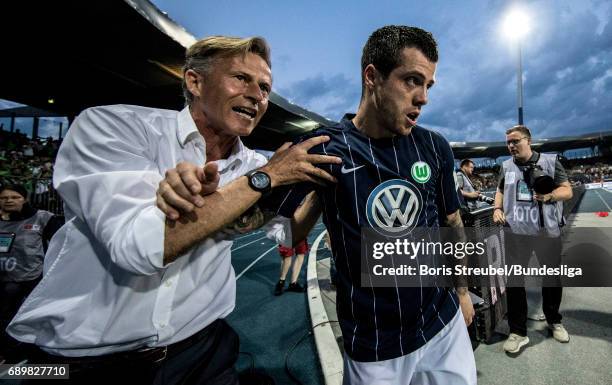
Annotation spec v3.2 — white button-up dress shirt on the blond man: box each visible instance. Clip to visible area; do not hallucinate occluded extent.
[7,105,278,356]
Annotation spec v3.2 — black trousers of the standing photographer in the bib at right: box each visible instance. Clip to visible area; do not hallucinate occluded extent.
[506,234,563,336]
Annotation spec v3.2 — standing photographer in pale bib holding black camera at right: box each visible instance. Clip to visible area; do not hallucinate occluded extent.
[493,125,572,353]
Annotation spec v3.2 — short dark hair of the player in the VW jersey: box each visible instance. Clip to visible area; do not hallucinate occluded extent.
[361,25,438,84]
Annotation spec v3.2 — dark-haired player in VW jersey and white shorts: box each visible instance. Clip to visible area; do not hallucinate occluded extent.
[158,26,476,384]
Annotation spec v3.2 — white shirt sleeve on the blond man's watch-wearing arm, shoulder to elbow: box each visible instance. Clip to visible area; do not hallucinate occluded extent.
[53,106,182,275]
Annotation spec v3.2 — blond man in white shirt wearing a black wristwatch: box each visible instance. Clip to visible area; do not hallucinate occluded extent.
[7,36,340,384]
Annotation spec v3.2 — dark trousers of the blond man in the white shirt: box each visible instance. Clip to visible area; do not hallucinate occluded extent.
[24,320,239,385]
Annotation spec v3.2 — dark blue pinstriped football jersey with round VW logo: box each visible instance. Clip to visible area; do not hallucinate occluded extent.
[264,115,459,361]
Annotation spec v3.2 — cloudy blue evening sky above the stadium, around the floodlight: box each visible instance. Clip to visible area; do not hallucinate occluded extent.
[149,0,612,141]
